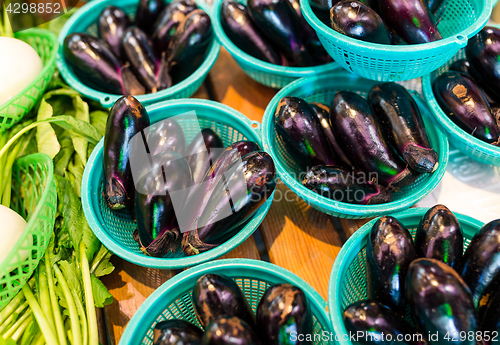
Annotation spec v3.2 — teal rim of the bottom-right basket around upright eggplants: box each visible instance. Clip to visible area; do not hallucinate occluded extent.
[328,207,484,345]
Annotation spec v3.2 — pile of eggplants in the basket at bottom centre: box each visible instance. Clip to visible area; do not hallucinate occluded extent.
[153,274,312,345]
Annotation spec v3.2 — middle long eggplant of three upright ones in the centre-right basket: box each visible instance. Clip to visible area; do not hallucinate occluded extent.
[330,91,416,187]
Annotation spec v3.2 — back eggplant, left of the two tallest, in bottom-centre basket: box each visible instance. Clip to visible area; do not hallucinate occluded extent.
[193,274,255,327]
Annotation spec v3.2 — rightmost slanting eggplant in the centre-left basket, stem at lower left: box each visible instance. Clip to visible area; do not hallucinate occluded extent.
[182,151,276,255]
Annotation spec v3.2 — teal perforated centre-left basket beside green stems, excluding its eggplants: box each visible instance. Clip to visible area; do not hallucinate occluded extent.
[82,99,274,269]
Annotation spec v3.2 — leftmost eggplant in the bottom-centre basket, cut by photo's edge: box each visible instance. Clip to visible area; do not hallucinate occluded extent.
[153,320,203,345]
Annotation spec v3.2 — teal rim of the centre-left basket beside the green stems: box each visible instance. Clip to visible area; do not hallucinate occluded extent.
[81,98,274,269]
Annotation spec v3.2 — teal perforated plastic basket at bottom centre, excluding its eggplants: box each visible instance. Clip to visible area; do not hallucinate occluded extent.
[119,259,334,345]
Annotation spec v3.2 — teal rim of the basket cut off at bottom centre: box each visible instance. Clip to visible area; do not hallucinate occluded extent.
[119,259,333,345]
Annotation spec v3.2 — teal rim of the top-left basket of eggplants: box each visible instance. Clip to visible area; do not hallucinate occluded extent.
[57,0,220,108]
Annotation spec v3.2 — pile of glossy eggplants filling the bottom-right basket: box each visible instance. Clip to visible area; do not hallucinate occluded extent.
[343,205,500,345]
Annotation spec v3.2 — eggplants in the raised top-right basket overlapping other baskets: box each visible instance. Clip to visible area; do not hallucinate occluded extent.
[328,0,446,44]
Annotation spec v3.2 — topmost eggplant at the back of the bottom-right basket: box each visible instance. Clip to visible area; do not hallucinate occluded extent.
[415,205,464,270]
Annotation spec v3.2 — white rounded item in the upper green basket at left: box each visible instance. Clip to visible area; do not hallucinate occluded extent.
[0,37,43,106]
